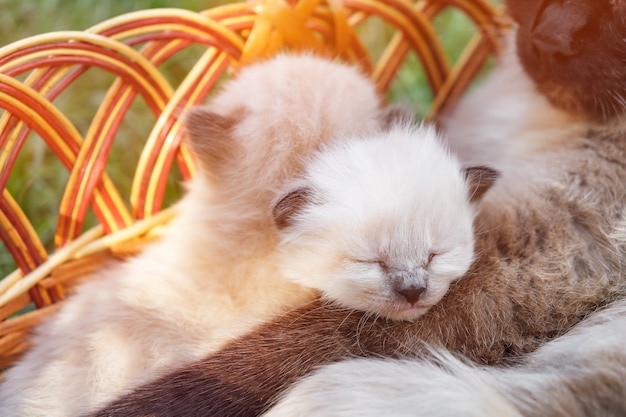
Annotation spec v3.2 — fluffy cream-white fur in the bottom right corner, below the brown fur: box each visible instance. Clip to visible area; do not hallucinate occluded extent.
[264,300,626,417]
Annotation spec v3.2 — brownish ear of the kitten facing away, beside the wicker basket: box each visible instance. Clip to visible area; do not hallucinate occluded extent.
[185,106,240,173]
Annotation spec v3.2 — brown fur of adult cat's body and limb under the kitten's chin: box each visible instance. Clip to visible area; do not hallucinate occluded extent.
[90,124,626,417]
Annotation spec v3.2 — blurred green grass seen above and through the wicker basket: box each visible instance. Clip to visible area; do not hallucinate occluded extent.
[0,0,500,279]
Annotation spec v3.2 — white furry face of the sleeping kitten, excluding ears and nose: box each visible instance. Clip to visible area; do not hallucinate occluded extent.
[280,126,474,320]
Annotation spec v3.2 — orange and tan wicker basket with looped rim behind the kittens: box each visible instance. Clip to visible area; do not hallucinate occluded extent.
[0,0,508,369]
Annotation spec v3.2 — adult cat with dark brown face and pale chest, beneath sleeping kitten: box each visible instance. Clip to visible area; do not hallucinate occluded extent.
[92,0,626,416]
